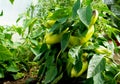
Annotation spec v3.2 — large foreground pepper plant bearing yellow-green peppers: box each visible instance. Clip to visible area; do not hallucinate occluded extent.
[31,0,119,84]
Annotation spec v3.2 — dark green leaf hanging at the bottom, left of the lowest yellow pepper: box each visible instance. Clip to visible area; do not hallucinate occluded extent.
[43,66,57,84]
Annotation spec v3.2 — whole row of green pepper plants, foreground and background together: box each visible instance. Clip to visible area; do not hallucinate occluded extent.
[0,0,120,84]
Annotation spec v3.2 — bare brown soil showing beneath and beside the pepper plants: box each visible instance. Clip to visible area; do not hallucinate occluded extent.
[0,53,120,84]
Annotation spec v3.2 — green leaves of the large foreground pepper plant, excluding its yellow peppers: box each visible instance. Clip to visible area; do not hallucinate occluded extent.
[31,0,119,84]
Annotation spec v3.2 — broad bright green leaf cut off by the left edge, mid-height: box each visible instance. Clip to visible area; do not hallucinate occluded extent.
[0,45,12,61]
